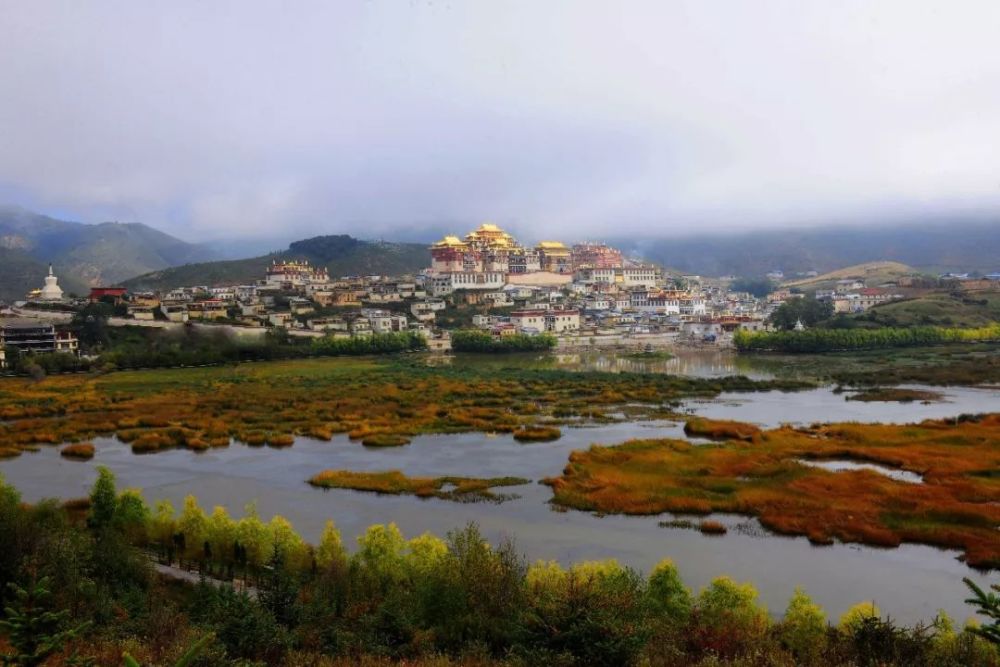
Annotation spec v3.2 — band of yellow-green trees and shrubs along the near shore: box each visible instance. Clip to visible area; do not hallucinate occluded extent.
[0,468,1000,667]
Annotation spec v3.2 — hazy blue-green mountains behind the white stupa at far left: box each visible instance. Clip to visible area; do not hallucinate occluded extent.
[0,206,216,300]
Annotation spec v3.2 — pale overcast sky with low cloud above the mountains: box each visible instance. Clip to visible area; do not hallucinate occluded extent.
[0,0,1000,241]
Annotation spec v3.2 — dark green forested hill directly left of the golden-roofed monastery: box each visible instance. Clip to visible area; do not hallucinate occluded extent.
[124,234,431,290]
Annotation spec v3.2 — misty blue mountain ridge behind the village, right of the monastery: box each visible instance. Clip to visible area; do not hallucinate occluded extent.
[618,216,1000,276]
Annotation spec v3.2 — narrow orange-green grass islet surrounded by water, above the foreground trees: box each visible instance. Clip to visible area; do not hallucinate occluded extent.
[308,470,530,502]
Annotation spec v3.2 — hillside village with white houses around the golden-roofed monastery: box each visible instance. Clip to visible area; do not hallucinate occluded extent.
[0,223,1000,370]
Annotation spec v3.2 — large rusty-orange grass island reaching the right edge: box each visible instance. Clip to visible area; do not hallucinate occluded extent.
[546,414,1000,568]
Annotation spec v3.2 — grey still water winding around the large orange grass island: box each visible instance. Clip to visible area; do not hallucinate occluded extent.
[0,388,1000,622]
